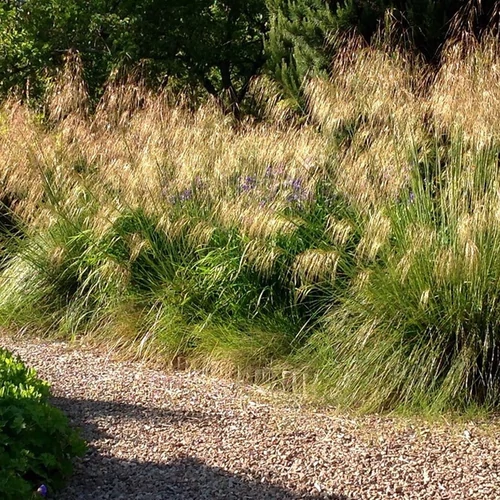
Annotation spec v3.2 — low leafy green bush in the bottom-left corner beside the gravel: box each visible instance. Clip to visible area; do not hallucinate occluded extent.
[0,349,84,500]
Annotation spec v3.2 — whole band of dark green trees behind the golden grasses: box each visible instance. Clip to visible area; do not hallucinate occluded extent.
[0,0,498,104]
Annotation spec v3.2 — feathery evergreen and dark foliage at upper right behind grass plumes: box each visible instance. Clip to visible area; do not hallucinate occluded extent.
[266,0,500,113]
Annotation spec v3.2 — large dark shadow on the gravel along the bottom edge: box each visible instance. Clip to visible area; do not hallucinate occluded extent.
[56,454,347,500]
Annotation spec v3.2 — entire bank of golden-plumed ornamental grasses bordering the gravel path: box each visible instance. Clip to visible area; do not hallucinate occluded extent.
[0,32,500,411]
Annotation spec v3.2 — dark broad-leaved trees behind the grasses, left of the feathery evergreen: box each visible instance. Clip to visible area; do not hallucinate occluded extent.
[0,0,267,107]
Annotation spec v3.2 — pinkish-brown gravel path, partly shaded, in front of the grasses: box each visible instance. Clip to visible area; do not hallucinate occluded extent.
[0,337,500,500]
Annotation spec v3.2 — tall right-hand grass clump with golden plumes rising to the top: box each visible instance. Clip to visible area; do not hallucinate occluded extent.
[299,35,500,412]
